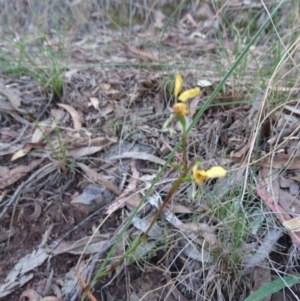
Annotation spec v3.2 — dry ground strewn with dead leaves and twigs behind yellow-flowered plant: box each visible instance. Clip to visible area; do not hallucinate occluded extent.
[0,0,300,301]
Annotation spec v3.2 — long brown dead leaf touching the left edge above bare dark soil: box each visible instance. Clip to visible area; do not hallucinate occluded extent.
[0,160,42,189]
